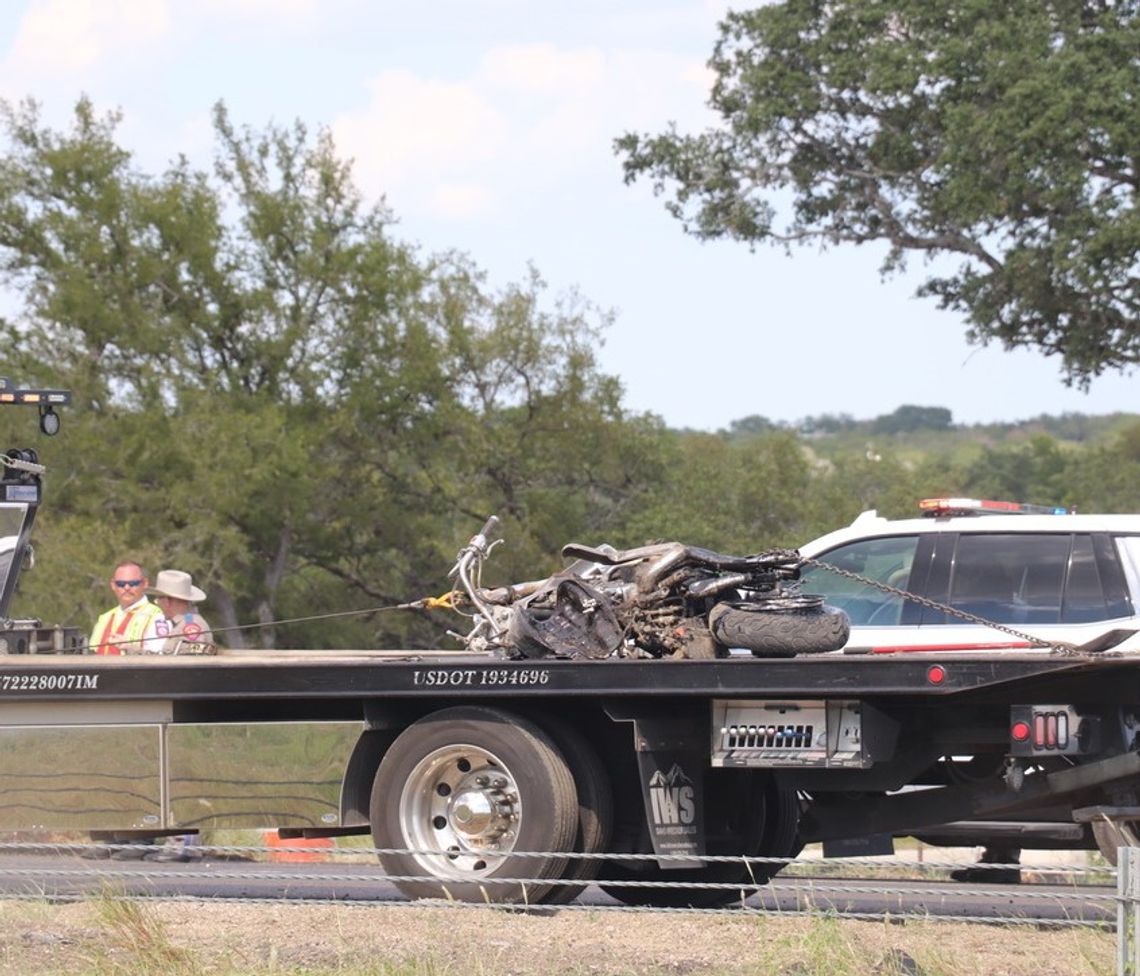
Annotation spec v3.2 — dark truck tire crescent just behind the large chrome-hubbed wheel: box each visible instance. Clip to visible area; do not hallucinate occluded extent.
[543,717,613,905]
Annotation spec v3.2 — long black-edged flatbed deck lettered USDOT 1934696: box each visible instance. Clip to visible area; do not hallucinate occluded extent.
[0,651,1140,708]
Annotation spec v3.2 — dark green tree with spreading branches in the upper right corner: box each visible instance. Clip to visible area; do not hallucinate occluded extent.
[617,0,1140,387]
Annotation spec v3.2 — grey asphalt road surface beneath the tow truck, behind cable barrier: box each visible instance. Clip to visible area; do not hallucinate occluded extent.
[0,854,1116,924]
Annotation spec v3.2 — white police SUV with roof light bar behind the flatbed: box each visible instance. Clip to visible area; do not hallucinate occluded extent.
[799,498,1140,653]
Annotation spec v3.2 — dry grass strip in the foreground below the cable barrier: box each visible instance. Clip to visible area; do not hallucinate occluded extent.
[0,894,1115,976]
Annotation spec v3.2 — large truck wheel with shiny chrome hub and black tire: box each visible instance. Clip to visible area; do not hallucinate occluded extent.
[369,707,578,904]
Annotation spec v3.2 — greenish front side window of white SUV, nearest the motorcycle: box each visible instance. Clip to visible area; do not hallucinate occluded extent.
[800,536,919,627]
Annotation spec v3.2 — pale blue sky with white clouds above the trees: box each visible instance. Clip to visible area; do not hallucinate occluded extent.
[0,0,1140,430]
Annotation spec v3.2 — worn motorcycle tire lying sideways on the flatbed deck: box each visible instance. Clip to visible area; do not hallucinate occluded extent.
[709,603,850,658]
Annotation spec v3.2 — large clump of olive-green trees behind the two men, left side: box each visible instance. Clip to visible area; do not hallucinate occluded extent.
[0,99,661,646]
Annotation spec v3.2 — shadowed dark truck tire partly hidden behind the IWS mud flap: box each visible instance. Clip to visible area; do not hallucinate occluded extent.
[601,770,801,909]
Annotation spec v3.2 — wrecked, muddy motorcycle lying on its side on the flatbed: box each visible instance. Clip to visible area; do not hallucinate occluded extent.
[450,515,849,659]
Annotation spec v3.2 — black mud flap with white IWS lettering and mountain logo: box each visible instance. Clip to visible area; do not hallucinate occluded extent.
[634,716,708,868]
